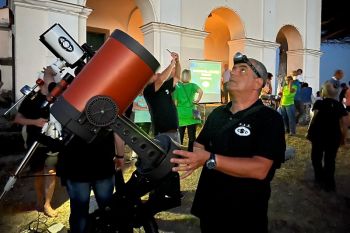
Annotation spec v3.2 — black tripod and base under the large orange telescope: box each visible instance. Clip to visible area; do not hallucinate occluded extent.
[88,171,181,233]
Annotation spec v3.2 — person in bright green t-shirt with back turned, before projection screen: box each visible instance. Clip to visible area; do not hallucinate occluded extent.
[173,69,203,151]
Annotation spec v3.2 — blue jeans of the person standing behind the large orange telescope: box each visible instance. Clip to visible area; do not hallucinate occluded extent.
[67,176,114,233]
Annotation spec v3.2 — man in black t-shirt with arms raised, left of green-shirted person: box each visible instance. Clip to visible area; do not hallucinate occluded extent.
[143,52,181,206]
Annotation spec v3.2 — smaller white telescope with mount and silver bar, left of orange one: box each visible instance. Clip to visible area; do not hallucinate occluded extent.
[0,24,94,200]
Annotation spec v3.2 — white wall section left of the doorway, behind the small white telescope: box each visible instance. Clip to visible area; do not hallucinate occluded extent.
[14,0,90,98]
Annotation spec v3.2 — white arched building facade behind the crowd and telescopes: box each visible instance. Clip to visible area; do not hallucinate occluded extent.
[6,0,321,100]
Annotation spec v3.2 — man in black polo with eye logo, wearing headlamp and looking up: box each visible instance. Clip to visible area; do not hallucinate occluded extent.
[171,53,286,233]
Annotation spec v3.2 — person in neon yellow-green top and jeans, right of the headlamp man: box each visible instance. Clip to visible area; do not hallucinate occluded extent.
[280,76,298,135]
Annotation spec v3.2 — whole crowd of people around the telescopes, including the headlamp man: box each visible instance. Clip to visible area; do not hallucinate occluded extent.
[6,49,350,233]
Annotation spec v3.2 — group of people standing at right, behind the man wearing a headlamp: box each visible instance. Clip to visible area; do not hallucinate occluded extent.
[258,66,350,192]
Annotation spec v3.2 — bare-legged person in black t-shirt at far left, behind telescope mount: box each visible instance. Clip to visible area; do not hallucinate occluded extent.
[14,66,57,217]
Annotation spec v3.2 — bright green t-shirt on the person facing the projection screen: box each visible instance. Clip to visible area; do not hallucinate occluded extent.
[173,83,201,127]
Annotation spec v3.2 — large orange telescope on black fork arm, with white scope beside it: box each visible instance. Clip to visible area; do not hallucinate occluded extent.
[40,24,178,180]
